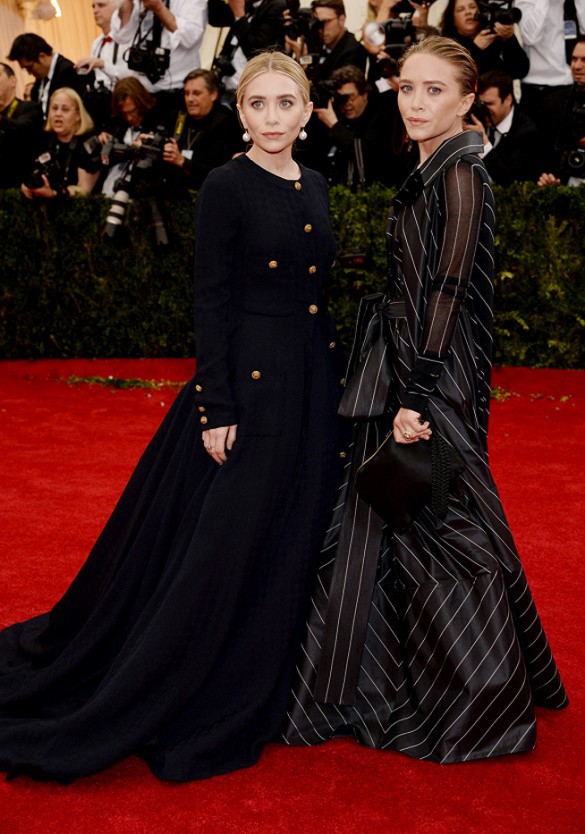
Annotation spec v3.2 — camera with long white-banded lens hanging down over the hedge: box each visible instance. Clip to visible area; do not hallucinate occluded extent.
[100,125,169,246]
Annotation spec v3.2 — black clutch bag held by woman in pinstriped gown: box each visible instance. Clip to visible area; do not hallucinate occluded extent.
[355,431,465,532]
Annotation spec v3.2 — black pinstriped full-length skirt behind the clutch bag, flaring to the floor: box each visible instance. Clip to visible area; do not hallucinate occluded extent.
[283,306,568,763]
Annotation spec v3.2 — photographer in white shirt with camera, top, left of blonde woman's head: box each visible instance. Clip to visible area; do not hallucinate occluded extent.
[111,0,207,114]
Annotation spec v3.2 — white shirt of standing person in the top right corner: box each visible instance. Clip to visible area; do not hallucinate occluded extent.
[515,0,585,87]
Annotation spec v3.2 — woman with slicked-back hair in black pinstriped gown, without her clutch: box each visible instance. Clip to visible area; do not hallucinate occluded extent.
[285,37,567,762]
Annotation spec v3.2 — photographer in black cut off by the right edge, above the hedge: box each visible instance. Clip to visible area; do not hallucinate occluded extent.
[538,35,585,185]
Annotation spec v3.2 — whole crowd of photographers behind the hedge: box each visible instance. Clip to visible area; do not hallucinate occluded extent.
[0,0,585,244]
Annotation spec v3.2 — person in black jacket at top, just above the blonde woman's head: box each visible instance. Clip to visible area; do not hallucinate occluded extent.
[208,0,286,101]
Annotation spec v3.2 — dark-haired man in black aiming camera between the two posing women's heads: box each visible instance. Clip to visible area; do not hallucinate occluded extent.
[314,66,416,188]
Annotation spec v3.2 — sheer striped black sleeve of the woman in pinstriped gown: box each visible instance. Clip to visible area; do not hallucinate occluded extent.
[402,161,483,413]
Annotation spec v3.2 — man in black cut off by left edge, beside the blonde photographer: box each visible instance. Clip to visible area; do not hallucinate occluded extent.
[0,63,43,188]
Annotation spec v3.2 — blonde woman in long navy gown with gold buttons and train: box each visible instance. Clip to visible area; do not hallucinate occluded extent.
[0,53,342,782]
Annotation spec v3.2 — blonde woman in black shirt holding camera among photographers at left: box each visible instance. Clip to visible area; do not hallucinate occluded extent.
[21,87,99,200]
